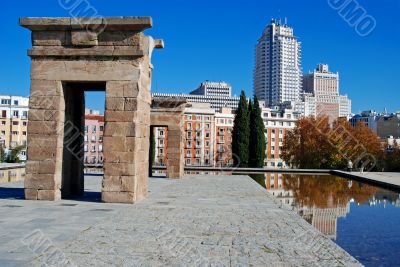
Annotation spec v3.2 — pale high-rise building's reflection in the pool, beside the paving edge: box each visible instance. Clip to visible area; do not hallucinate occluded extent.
[296,203,350,240]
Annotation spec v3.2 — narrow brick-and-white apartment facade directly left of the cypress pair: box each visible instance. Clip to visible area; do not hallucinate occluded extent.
[215,108,235,167]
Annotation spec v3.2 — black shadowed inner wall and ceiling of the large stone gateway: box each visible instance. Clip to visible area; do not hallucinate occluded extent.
[61,82,106,198]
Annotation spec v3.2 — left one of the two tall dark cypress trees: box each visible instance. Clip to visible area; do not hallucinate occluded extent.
[232,90,250,167]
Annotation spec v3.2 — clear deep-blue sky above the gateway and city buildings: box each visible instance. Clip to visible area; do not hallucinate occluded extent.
[0,0,400,112]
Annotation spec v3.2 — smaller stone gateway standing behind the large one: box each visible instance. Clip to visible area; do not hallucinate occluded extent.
[151,99,187,179]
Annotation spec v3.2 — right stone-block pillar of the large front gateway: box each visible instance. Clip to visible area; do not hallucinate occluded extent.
[102,77,150,203]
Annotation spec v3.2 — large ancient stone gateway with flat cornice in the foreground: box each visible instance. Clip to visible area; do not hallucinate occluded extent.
[20,17,182,203]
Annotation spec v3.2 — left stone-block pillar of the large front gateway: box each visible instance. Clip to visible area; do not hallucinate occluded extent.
[25,80,65,200]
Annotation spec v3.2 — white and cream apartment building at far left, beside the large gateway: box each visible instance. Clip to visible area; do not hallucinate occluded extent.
[0,95,29,160]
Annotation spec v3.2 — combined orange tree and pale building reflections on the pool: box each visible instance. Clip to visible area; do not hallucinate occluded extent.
[255,173,400,240]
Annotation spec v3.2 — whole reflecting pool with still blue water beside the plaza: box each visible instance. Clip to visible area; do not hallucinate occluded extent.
[250,173,400,266]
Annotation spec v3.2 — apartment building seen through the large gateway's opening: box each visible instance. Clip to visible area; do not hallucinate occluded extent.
[84,113,104,164]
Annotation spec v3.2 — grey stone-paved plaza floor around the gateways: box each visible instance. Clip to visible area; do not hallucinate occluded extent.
[0,175,360,266]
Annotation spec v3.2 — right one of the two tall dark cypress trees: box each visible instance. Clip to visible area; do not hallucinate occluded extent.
[249,96,266,168]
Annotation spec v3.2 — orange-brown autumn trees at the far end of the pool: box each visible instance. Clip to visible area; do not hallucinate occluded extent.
[282,117,381,169]
